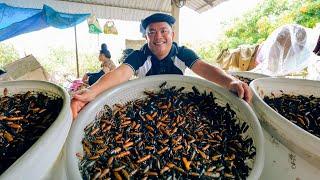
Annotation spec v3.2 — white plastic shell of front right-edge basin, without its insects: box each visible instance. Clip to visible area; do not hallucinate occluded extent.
[250,78,320,167]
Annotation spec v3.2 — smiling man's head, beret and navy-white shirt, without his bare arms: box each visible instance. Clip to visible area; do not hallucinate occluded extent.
[124,13,199,77]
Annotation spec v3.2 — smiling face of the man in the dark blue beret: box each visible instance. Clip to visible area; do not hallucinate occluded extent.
[146,22,174,60]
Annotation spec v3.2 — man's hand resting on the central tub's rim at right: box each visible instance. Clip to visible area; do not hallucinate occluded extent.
[228,80,252,103]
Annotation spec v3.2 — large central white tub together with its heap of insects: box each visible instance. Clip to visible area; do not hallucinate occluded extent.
[65,75,264,179]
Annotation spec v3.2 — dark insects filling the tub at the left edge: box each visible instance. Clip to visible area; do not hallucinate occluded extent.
[0,89,63,174]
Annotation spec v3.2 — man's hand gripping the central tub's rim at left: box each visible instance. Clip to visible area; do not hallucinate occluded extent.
[71,89,95,120]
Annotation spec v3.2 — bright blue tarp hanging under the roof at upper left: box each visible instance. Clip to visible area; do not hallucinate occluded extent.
[0,3,90,41]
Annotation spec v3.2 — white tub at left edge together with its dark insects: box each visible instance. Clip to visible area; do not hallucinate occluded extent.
[0,80,72,179]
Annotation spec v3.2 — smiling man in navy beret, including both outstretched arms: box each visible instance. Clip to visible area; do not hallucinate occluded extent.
[71,13,252,118]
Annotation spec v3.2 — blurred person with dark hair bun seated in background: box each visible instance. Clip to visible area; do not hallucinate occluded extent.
[82,43,116,86]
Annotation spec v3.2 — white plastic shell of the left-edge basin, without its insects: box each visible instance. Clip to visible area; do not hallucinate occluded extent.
[0,80,72,180]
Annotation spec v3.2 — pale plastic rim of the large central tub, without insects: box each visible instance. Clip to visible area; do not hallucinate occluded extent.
[66,75,265,179]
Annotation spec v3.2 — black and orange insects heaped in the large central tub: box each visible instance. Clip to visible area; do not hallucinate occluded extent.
[77,83,256,179]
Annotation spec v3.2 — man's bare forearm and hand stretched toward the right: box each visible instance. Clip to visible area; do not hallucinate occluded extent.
[191,59,252,102]
